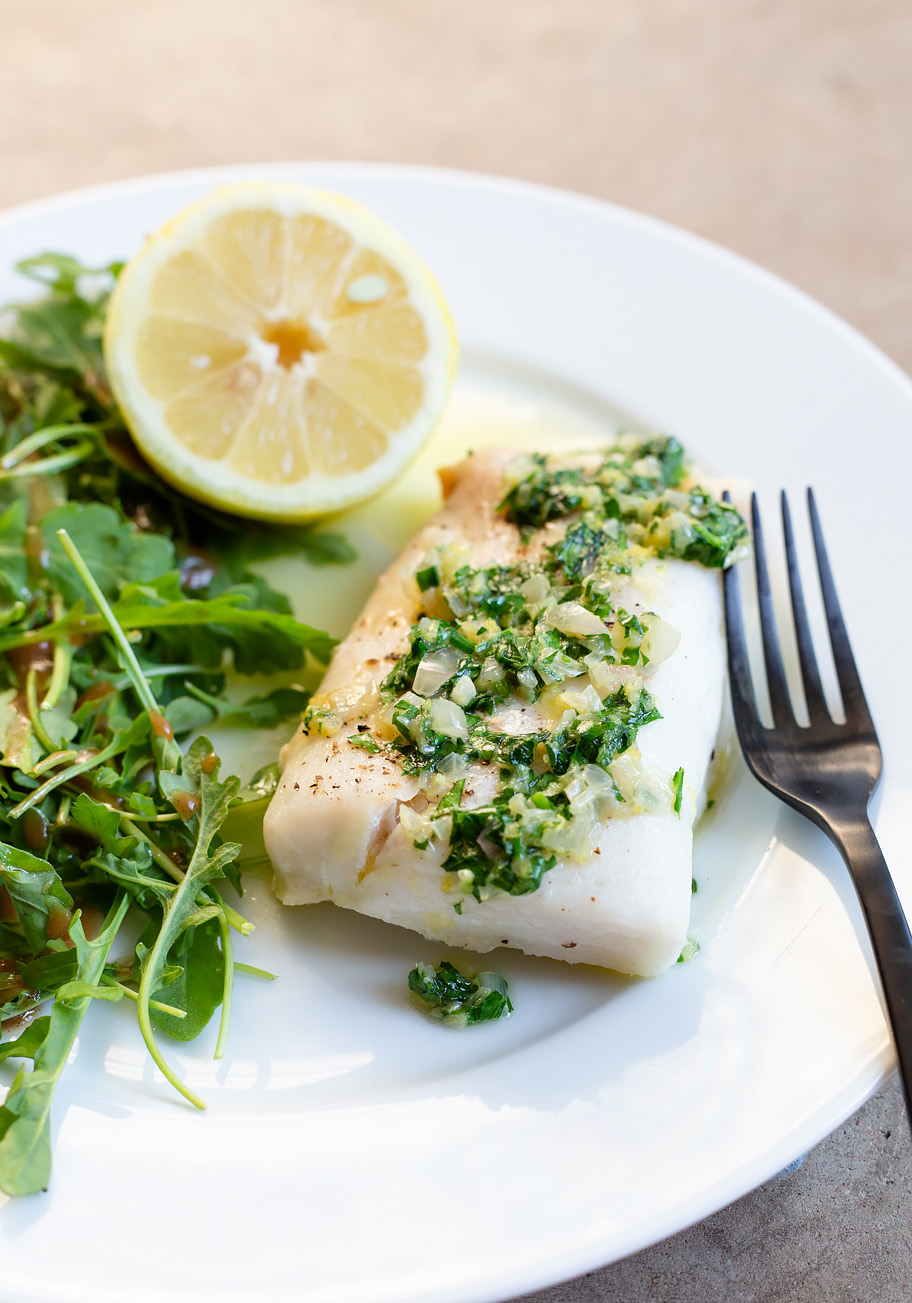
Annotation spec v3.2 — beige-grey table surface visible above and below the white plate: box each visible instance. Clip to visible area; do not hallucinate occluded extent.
[0,0,912,1303]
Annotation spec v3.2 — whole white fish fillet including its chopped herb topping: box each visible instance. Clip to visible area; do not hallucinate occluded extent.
[264,438,745,976]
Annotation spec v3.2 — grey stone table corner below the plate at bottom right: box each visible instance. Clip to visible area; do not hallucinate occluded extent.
[521,1078,912,1303]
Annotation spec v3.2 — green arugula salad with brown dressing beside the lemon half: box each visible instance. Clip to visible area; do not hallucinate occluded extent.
[0,254,353,1195]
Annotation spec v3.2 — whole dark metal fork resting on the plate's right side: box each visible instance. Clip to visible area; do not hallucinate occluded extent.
[724,489,912,1121]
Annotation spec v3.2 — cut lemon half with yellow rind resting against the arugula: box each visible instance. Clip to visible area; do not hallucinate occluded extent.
[104,182,456,521]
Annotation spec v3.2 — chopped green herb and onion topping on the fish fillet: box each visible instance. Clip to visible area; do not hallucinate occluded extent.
[349,437,748,912]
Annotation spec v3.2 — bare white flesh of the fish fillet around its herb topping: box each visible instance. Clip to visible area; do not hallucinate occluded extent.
[266,450,724,976]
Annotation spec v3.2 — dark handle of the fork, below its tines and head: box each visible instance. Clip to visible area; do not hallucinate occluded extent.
[827,813,912,1118]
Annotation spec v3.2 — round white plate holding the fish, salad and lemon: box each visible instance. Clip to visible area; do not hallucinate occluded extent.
[0,164,912,1303]
